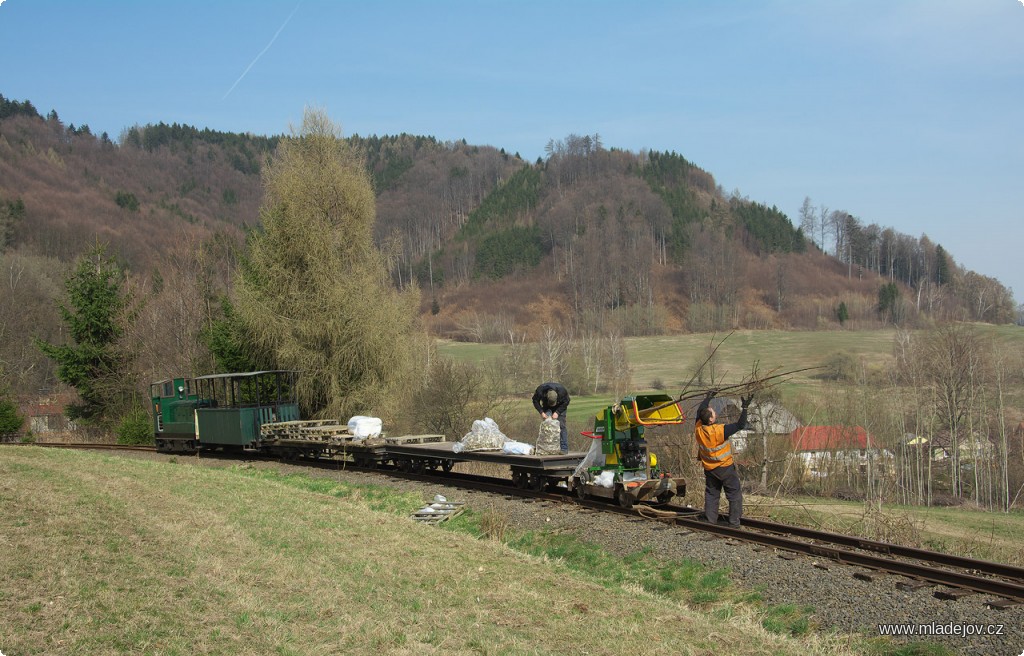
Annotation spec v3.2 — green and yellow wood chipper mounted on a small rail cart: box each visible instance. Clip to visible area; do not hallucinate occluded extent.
[572,394,686,508]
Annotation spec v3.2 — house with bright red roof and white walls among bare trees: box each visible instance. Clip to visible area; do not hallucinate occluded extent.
[790,426,892,477]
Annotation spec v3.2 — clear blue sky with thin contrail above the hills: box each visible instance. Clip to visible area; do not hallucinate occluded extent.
[0,0,1024,302]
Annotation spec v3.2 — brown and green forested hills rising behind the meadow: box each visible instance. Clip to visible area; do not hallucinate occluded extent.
[0,96,1015,401]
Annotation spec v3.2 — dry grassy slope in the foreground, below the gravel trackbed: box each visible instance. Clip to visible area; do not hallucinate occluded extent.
[0,446,937,656]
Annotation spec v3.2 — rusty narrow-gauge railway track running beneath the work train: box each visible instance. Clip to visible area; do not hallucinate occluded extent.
[16,442,1024,607]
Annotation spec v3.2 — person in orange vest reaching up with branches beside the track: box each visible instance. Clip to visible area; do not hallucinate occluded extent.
[693,390,754,527]
